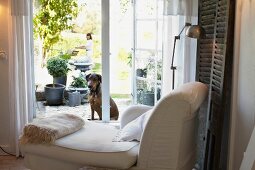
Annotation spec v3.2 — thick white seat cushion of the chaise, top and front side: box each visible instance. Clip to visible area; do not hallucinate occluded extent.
[22,122,139,169]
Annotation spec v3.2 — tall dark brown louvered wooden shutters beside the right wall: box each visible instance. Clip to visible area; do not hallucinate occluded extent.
[197,0,235,170]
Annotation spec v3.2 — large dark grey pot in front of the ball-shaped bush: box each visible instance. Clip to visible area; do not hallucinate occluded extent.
[44,84,66,106]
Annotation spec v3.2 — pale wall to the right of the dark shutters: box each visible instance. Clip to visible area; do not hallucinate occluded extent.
[229,0,255,170]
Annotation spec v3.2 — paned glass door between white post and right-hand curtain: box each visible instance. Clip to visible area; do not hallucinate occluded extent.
[133,0,163,106]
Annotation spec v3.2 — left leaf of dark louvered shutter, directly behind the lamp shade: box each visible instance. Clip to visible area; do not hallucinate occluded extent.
[196,0,216,167]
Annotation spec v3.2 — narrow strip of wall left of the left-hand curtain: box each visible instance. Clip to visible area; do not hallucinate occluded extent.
[0,0,10,154]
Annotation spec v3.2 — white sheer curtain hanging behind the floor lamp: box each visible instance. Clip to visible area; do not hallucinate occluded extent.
[162,0,198,95]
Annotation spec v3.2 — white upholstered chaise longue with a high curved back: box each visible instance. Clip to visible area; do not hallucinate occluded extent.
[21,82,208,170]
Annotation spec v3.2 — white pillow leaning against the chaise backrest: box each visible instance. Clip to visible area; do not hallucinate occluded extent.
[113,109,152,142]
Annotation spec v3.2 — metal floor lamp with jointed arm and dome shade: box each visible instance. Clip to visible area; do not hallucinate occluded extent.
[170,23,205,89]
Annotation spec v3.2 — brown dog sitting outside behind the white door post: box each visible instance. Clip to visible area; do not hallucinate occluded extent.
[86,73,119,120]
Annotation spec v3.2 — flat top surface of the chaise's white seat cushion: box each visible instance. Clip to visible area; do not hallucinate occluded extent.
[55,121,138,152]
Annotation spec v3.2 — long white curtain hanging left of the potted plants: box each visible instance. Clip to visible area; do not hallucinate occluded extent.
[9,0,35,156]
